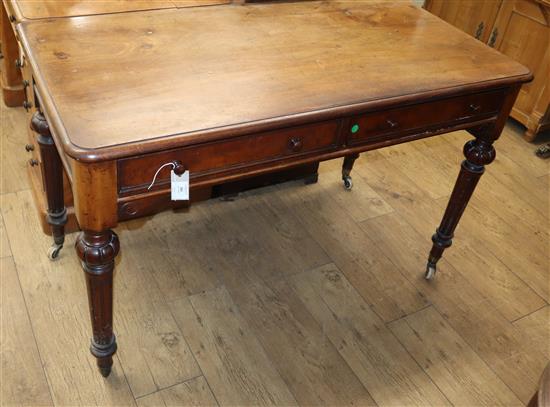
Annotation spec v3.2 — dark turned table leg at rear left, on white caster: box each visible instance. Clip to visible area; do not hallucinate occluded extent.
[31,112,67,260]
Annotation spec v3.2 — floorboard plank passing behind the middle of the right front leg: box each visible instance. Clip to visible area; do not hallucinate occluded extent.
[358,155,545,321]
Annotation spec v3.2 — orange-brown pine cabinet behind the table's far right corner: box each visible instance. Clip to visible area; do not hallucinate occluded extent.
[425,0,550,141]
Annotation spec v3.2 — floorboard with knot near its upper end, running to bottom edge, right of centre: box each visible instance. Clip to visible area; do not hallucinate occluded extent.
[292,264,449,405]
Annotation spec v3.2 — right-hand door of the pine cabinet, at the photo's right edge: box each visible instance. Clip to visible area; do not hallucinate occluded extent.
[494,0,550,124]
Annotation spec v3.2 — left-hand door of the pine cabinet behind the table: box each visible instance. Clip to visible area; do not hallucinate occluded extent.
[425,0,502,42]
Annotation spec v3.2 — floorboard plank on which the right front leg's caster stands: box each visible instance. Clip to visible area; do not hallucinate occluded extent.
[363,213,546,403]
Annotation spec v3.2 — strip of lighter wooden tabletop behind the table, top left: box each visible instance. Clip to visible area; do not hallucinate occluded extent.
[8,0,231,20]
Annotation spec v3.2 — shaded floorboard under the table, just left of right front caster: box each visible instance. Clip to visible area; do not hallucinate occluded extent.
[279,177,426,321]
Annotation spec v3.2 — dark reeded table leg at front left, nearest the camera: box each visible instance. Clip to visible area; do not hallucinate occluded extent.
[75,230,120,377]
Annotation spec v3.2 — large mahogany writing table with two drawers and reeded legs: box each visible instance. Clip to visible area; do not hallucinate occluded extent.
[18,1,532,376]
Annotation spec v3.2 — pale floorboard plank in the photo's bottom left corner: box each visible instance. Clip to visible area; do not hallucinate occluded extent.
[0,257,53,406]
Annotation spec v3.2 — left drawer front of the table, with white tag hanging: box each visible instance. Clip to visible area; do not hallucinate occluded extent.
[118,121,339,195]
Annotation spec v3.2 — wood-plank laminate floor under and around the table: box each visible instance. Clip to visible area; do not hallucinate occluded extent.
[0,99,550,407]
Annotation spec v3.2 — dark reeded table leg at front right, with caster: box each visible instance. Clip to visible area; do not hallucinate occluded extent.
[425,133,496,280]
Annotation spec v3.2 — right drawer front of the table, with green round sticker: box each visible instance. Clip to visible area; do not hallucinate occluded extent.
[346,90,506,145]
